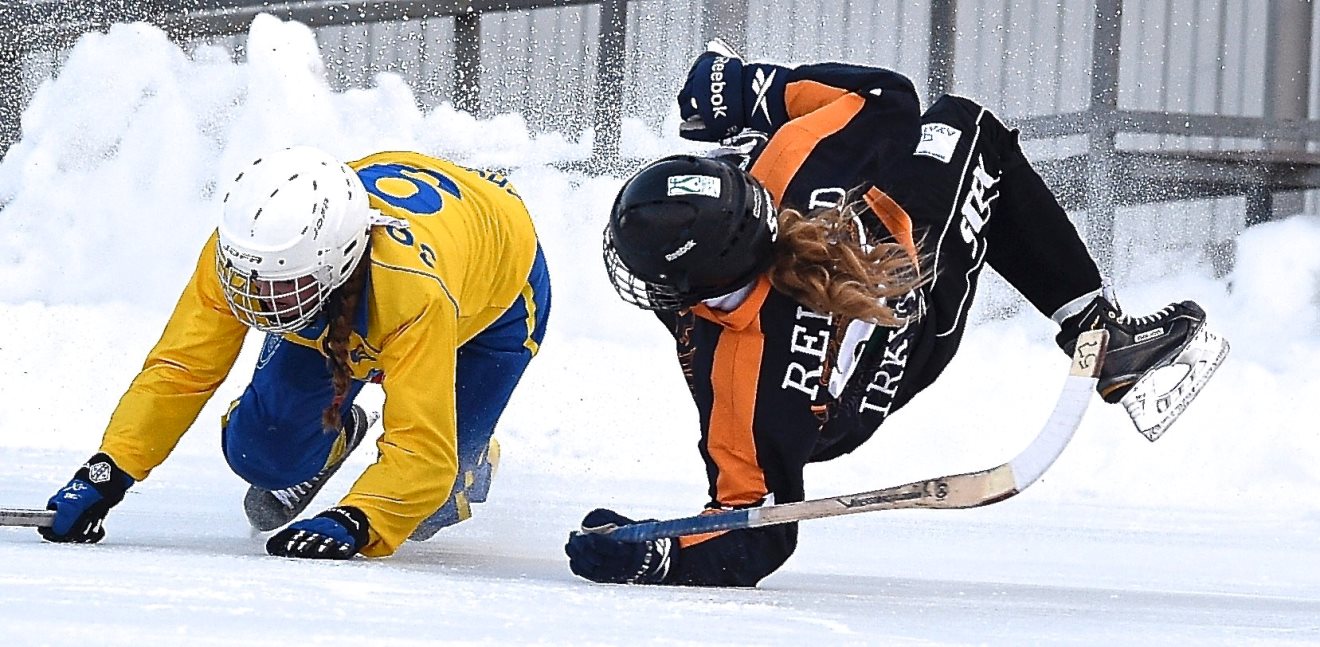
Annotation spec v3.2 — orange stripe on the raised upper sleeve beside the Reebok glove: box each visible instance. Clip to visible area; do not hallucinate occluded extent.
[751,91,866,205]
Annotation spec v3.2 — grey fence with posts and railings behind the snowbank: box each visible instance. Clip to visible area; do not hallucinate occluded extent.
[0,0,1320,265]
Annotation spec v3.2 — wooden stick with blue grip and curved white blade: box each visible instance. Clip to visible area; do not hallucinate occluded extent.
[604,330,1109,541]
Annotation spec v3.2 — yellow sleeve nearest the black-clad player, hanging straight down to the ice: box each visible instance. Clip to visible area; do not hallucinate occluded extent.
[339,298,458,557]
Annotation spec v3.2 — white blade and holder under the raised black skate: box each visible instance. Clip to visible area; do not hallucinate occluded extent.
[1119,324,1229,442]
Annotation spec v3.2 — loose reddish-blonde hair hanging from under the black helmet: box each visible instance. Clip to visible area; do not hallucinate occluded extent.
[770,201,927,326]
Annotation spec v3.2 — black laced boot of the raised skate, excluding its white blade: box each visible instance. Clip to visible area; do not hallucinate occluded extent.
[1055,297,1205,403]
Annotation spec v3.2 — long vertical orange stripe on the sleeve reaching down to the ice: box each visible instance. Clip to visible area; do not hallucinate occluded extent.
[706,287,770,506]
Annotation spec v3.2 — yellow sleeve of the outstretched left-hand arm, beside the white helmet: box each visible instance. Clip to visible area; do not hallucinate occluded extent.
[100,234,247,481]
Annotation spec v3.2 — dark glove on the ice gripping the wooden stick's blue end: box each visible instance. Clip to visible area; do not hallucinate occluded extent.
[564,508,678,584]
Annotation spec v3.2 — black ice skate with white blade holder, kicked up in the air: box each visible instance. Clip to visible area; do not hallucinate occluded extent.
[1056,296,1229,441]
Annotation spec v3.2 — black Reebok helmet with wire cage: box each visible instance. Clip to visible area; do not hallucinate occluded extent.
[605,154,777,310]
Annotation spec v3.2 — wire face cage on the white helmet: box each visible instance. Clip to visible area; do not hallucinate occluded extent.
[215,250,331,333]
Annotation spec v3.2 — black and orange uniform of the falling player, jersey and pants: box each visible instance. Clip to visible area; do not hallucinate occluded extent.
[659,63,1100,586]
